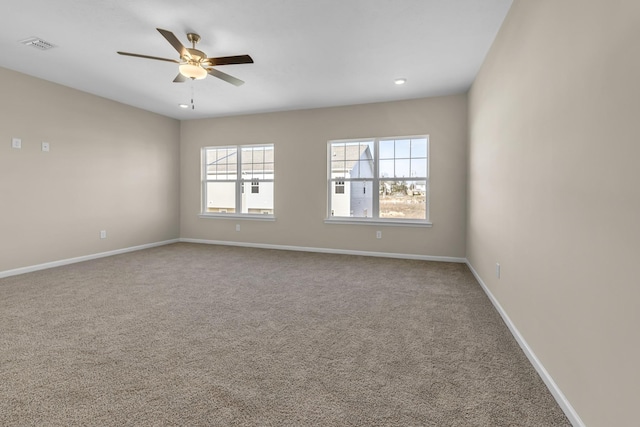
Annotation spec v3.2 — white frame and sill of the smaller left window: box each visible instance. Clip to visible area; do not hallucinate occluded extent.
[199,144,275,221]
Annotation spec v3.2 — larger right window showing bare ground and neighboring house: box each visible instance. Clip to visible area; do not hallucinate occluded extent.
[327,136,429,225]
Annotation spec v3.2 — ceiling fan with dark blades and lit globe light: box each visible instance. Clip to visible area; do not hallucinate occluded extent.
[118,28,253,86]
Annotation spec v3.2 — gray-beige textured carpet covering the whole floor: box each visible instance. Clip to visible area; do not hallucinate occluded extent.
[0,243,570,427]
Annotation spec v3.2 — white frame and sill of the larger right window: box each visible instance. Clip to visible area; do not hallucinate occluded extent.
[324,135,433,227]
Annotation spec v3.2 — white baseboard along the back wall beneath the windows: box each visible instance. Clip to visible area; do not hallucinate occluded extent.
[180,238,467,264]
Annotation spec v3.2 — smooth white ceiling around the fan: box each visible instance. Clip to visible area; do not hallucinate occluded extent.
[0,0,512,119]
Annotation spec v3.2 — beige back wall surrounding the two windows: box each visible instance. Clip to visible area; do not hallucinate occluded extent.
[180,95,467,257]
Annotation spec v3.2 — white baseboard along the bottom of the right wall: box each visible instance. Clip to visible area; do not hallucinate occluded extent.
[466,260,585,427]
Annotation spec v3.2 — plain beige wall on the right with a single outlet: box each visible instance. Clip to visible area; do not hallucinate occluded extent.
[467,0,640,427]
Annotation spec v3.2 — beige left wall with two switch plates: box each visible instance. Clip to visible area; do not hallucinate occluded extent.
[0,68,180,272]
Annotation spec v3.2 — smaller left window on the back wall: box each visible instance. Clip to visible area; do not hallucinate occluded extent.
[202,144,274,218]
